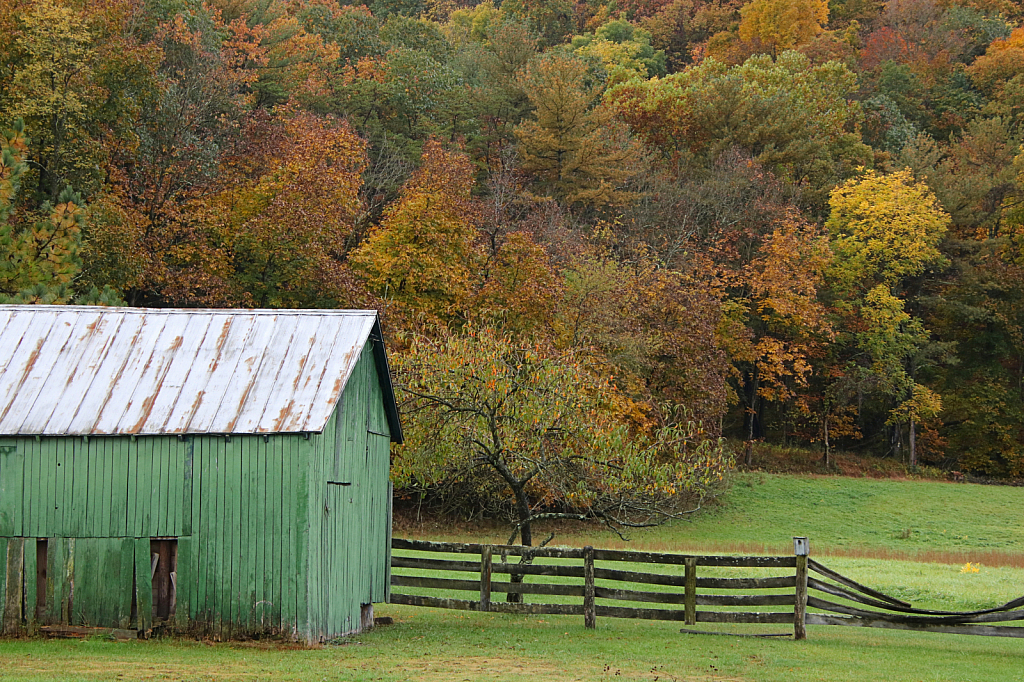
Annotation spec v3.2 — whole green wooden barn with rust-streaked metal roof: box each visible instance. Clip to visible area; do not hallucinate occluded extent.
[0,305,401,642]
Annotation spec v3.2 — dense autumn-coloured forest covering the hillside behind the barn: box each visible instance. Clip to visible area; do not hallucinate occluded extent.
[0,0,1024,499]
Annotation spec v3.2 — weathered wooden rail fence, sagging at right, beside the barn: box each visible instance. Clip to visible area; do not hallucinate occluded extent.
[389,538,1024,639]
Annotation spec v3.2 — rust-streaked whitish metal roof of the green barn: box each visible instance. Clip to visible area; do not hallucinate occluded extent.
[0,305,401,442]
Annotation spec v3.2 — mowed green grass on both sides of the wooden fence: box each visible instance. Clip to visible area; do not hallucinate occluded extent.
[0,474,1024,682]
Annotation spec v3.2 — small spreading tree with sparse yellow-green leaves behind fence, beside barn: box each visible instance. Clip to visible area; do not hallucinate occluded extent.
[392,328,730,546]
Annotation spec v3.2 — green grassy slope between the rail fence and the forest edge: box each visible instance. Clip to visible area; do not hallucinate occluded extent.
[395,473,1024,567]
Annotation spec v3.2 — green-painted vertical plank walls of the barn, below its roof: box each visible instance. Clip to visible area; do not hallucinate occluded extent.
[0,343,390,641]
